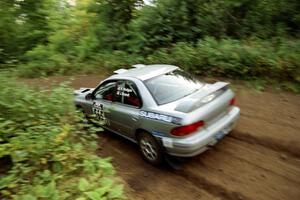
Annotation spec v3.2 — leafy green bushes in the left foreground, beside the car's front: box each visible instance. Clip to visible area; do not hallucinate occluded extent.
[0,75,124,200]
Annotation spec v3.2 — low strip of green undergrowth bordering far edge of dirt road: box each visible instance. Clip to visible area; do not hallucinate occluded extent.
[19,37,300,91]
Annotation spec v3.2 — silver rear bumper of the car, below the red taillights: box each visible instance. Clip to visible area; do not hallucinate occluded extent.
[161,106,240,157]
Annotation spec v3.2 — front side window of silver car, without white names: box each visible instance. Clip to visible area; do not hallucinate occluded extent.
[94,81,116,101]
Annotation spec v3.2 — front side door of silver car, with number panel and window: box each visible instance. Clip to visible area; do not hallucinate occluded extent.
[92,81,117,128]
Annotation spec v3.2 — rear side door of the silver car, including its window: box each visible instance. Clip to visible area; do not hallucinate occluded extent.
[111,80,142,139]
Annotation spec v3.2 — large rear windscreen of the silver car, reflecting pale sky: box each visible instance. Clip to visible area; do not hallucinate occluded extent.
[145,70,203,105]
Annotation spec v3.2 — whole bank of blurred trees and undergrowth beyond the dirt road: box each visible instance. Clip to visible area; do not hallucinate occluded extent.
[0,0,300,91]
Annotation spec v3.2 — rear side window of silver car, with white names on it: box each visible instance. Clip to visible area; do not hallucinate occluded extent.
[115,81,142,107]
